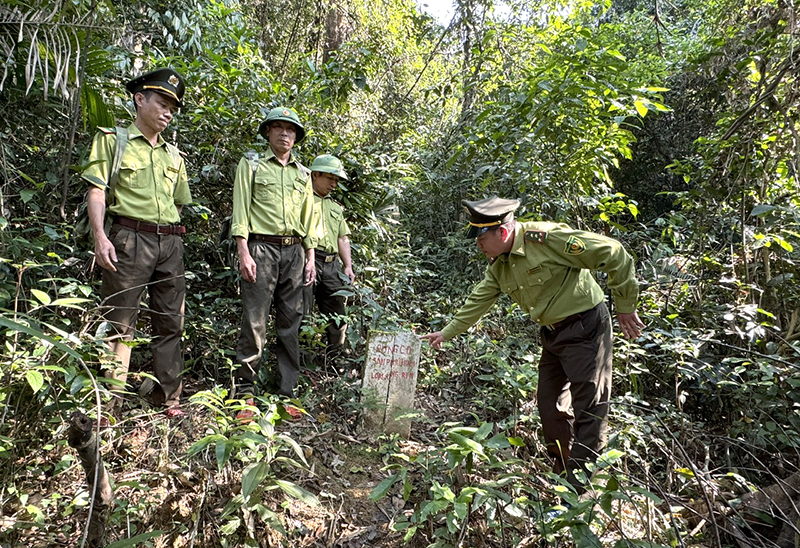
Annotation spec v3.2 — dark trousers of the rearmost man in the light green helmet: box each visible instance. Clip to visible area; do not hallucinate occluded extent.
[303,250,347,352]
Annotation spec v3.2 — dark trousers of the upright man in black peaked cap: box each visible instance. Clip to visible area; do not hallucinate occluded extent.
[100,224,186,407]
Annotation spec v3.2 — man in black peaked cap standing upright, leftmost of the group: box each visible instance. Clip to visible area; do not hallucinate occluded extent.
[83,68,192,417]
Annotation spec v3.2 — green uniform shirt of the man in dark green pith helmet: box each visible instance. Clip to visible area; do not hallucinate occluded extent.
[231,149,316,249]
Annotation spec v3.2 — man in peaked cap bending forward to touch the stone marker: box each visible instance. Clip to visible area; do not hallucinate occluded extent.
[422,196,643,492]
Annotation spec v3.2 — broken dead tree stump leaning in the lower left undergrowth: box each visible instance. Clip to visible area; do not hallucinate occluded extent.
[67,411,114,548]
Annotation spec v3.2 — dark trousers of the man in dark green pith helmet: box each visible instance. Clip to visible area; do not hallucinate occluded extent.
[236,242,305,397]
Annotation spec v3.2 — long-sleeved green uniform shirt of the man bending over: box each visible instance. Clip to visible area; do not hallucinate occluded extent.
[442,223,639,339]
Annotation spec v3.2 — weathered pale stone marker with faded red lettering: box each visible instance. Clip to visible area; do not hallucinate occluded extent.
[361,331,421,437]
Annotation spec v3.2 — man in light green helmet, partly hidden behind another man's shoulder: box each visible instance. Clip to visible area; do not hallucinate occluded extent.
[305,154,356,355]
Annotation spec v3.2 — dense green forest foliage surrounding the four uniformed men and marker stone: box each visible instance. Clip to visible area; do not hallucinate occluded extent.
[0,0,800,547]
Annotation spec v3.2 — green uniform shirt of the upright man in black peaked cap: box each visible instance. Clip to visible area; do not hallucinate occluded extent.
[82,124,192,224]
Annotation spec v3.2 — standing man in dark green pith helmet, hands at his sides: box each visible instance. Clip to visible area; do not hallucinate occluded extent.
[231,107,316,420]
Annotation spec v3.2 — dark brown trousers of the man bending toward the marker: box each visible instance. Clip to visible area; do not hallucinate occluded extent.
[537,303,614,486]
